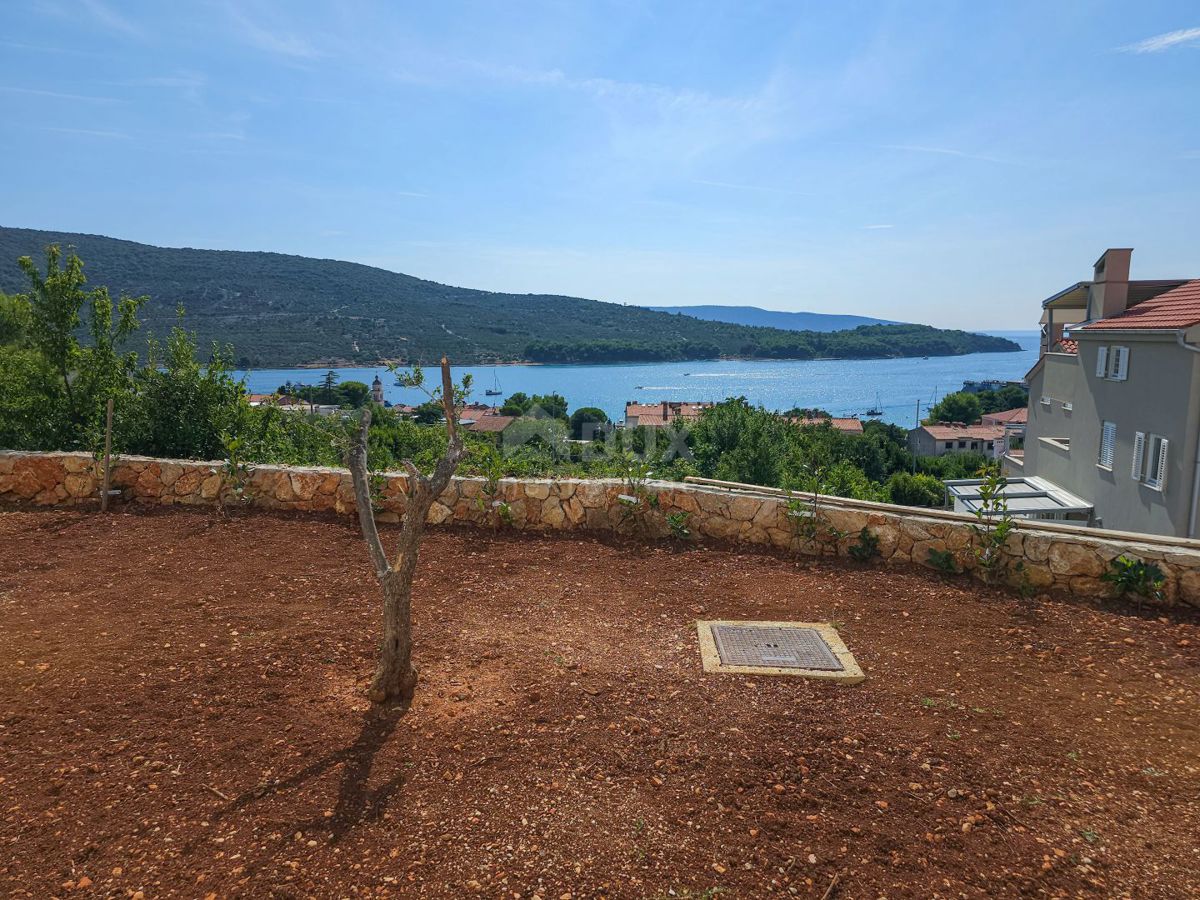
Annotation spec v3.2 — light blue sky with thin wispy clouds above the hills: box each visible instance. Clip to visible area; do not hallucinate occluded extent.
[0,0,1200,329]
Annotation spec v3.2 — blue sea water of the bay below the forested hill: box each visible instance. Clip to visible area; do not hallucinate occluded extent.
[238,331,1038,427]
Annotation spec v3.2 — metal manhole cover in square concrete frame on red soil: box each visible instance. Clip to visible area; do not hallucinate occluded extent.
[697,622,864,684]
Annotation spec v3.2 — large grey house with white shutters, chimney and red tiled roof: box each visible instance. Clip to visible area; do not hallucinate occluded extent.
[1004,250,1200,538]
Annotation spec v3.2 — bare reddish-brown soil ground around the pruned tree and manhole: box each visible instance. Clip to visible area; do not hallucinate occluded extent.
[0,511,1200,900]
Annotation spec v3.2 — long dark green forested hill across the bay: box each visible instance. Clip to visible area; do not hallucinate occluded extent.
[0,228,1019,367]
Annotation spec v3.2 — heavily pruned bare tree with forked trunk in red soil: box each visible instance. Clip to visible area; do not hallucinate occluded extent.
[348,356,470,704]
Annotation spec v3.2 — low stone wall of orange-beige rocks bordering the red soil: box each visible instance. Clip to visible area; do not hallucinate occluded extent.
[0,451,1200,607]
